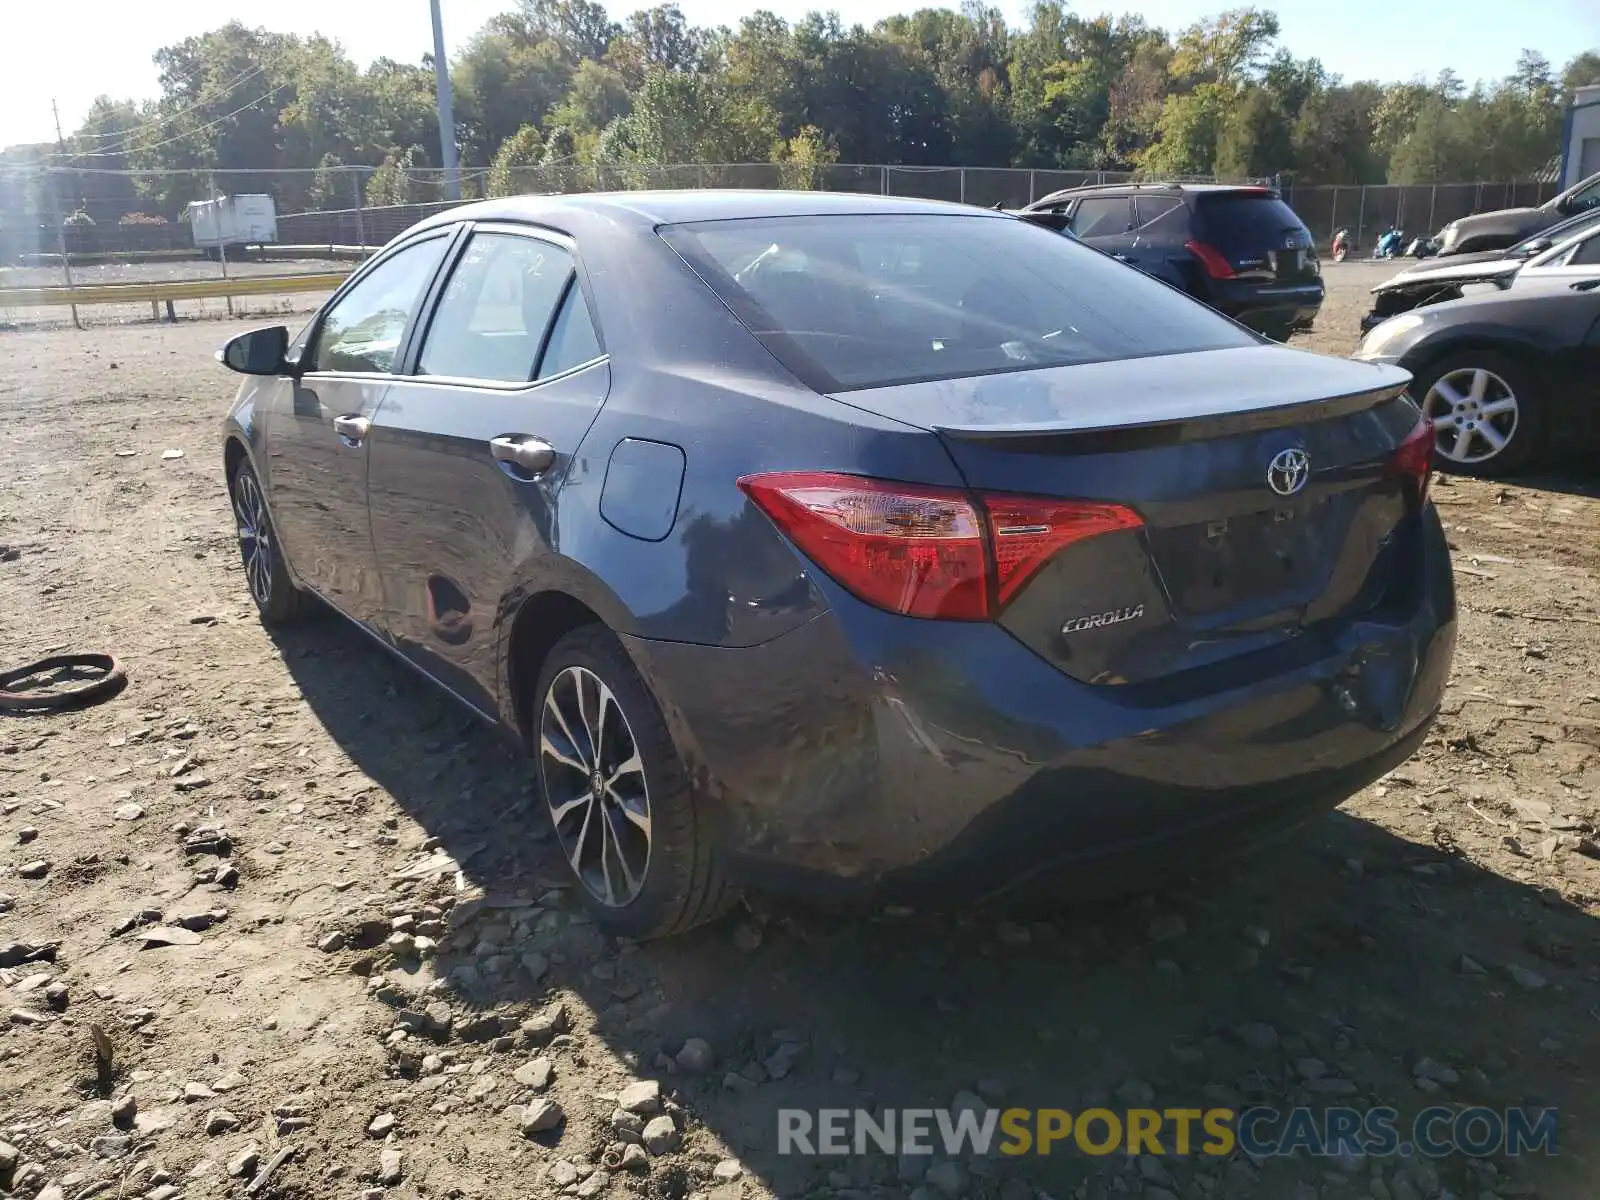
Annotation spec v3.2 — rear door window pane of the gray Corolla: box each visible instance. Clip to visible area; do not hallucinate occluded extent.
[418,232,573,384]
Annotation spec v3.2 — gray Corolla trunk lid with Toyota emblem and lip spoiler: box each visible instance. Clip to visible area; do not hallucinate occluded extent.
[837,347,1418,683]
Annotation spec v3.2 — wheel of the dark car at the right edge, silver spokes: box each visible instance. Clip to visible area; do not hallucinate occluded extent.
[1411,350,1546,478]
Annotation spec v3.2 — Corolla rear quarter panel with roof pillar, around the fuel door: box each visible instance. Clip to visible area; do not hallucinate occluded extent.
[550,229,960,659]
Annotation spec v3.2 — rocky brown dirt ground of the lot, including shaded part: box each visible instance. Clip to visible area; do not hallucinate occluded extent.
[0,264,1600,1200]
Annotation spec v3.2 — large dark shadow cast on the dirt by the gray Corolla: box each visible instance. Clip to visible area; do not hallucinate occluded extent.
[268,619,1600,1200]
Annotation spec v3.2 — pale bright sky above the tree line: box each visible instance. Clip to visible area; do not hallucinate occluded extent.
[0,0,1600,147]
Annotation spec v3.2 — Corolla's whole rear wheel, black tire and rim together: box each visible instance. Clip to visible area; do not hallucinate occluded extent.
[528,624,736,941]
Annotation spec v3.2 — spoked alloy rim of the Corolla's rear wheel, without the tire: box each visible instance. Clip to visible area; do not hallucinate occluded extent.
[539,666,651,909]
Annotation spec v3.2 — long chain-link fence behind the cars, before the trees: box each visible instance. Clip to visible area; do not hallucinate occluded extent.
[0,163,1558,305]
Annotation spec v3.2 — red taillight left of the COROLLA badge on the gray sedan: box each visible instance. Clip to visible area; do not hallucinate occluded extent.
[739,470,1141,621]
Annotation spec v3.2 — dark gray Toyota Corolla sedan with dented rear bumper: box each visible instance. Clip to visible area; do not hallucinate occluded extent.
[219,192,1454,936]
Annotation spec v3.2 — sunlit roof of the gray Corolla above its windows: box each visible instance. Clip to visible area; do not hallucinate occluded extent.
[406,189,1003,227]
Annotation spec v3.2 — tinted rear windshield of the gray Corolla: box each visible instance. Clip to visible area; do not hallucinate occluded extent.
[661,213,1256,392]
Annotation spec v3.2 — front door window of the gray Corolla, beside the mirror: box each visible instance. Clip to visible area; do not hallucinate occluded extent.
[310,237,450,373]
